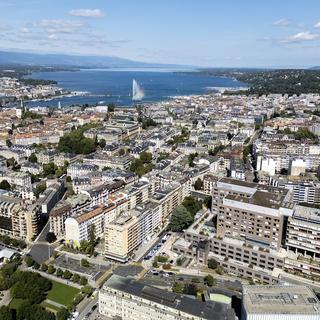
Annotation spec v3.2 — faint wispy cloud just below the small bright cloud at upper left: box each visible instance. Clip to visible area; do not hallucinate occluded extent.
[33,19,83,33]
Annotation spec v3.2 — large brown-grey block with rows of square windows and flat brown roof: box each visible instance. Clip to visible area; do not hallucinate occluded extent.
[212,178,294,250]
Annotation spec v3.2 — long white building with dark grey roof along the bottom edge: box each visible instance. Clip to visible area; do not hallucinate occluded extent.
[99,275,236,320]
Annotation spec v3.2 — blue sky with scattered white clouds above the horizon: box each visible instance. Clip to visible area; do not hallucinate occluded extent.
[0,0,320,67]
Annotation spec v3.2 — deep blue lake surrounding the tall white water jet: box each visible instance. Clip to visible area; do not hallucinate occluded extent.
[28,69,245,106]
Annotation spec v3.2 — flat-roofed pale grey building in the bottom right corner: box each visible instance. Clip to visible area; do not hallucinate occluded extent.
[242,286,320,320]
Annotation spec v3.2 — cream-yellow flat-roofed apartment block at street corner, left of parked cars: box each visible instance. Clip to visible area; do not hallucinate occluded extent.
[105,202,162,262]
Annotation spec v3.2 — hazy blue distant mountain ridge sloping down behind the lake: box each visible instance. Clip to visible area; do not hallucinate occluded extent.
[0,51,190,68]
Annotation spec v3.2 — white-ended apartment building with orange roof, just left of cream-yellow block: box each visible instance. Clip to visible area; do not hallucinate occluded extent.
[65,203,116,247]
